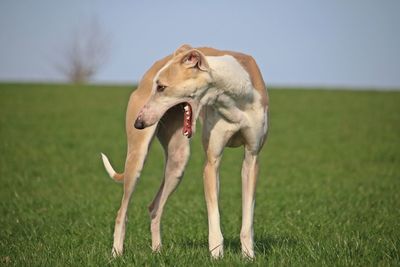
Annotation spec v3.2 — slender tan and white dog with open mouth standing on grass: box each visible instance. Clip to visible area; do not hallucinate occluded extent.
[102,45,269,258]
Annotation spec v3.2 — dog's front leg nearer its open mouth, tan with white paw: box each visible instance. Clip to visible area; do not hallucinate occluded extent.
[204,155,224,258]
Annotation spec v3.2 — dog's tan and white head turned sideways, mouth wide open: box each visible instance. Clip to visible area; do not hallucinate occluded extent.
[134,45,212,137]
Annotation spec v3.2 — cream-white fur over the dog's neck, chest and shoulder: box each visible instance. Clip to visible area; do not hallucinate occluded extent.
[206,55,268,151]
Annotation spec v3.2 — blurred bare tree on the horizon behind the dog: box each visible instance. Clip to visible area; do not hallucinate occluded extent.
[56,20,110,84]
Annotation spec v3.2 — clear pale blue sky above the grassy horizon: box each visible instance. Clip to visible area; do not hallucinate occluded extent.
[0,0,400,88]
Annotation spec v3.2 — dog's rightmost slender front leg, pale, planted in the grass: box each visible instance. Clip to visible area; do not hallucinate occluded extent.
[240,148,258,258]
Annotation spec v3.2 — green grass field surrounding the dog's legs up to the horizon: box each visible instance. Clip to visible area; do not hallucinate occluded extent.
[0,84,400,266]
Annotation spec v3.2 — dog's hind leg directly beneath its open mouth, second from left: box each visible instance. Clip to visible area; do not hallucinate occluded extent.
[149,107,190,251]
